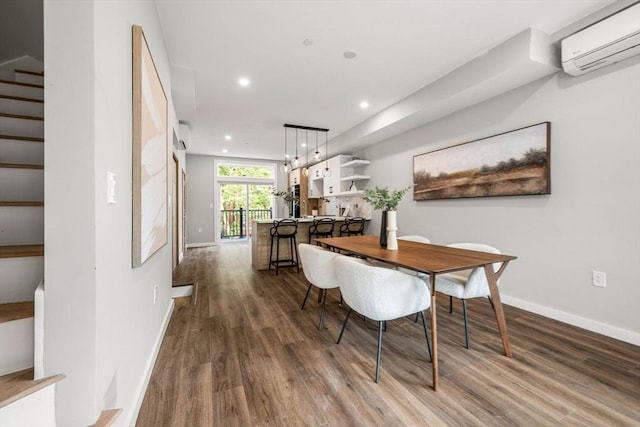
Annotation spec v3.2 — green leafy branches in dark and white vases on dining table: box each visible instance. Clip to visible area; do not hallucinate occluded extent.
[362,186,411,250]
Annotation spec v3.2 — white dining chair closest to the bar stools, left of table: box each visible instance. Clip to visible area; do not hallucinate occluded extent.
[298,243,341,330]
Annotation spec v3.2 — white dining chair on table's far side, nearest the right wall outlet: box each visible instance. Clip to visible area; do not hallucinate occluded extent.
[436,243,502,349]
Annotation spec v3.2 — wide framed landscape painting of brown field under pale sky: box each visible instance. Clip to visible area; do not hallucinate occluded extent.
[413,122,551,200]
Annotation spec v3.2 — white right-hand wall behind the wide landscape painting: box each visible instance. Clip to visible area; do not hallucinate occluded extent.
[360,57,640,344]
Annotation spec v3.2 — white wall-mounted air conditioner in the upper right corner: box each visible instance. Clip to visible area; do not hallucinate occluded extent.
[562,3,640,76]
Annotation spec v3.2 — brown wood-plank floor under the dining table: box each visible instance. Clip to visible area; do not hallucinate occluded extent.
[137,243,640,427]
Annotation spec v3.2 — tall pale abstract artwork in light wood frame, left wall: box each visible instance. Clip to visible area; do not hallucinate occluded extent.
[131,25,168,267]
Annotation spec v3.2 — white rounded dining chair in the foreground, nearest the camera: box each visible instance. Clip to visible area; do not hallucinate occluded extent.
[334,257,431,382]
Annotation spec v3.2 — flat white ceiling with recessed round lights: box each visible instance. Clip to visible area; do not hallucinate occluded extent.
[156,0,612,160]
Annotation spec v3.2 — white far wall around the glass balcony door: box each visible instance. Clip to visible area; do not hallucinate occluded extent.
[186,154,288,246]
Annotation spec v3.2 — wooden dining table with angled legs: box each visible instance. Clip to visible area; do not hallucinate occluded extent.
[316,235,517,391]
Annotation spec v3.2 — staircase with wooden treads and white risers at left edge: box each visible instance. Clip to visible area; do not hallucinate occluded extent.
[0,70,64,426]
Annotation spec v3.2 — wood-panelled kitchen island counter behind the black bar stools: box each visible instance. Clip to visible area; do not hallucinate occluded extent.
[251,216,369,270]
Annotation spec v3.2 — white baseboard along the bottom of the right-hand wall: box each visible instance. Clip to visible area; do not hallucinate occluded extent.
[500,295,640,345]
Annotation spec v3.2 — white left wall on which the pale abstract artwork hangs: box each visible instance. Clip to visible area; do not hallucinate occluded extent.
[44,0,176,426]
